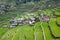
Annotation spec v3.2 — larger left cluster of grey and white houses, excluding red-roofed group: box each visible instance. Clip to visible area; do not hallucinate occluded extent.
[4,18,35,28]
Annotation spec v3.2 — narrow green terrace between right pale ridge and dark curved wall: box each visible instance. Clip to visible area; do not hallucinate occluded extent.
[42,22,53,40]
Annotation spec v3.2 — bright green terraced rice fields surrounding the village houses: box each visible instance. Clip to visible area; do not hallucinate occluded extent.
[0,2,60,40]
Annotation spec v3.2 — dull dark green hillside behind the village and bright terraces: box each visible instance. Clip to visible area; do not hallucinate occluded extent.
[0,0,60,21]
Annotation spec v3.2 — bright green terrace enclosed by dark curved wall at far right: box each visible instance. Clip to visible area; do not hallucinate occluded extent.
[49,19,60,38]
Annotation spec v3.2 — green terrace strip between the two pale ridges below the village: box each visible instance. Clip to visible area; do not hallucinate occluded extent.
[34,22,43,40]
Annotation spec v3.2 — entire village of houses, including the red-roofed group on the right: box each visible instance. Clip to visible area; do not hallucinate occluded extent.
[4,14,50,28]
